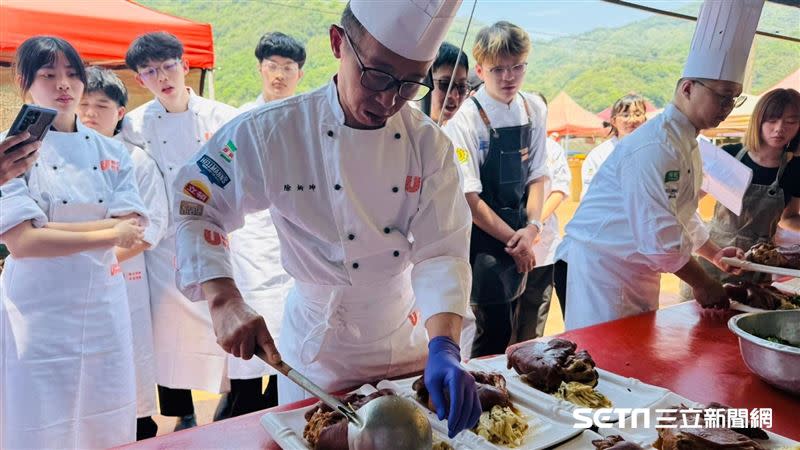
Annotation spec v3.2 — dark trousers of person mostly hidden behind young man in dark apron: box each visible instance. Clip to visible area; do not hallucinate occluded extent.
[510,264,553,344]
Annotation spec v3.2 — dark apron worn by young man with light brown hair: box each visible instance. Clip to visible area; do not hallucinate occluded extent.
[469,94,532,305]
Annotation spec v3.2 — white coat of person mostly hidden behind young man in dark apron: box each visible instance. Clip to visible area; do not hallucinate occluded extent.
[533,138,572,267]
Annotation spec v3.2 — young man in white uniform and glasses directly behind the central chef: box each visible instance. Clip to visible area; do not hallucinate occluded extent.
[222,32,306,420]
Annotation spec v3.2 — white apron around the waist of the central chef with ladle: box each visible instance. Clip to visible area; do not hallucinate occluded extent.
[278,270,427,404]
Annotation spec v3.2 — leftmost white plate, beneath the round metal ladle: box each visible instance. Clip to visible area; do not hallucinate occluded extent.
[261,384,460,450]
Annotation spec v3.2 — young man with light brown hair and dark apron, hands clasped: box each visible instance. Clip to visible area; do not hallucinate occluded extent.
[444,22,549,358]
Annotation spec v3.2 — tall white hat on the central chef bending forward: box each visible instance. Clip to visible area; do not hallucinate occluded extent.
[350,0,461,61]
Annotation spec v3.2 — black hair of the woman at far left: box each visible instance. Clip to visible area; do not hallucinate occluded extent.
[14,36,86,96]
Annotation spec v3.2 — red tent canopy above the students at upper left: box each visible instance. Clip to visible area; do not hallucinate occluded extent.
[0,0,214,69]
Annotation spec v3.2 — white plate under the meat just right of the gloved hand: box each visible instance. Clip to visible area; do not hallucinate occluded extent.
[467,355,669,416]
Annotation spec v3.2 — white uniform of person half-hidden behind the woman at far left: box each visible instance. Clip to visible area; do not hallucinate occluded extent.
[117,135,169,417]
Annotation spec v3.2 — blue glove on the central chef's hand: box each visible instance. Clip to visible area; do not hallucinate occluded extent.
[425,336,481,438]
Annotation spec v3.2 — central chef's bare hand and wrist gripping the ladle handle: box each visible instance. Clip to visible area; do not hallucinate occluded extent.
[203,284,281,364]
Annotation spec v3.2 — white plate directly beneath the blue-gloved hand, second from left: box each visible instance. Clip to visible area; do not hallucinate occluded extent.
[378,377,583,450]
